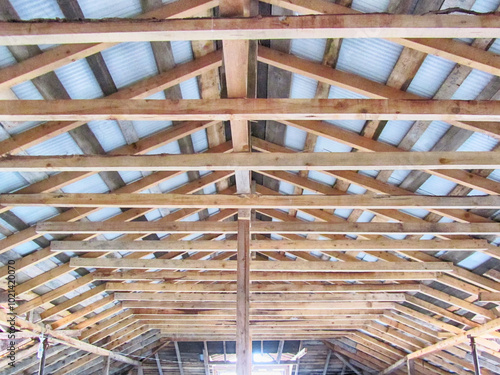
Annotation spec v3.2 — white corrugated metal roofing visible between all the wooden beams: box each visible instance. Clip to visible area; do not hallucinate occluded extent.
[0,0,500,374]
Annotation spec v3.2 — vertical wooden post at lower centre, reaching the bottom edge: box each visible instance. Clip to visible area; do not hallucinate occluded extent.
[236,217,252,375]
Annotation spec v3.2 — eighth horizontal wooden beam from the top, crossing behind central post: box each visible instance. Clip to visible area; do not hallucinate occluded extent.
[92,270,441,280]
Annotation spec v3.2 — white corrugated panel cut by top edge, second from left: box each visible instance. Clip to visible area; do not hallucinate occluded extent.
[78,0,142,18]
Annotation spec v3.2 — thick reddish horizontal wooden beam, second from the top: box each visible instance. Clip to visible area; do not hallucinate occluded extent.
[0,99,500,121]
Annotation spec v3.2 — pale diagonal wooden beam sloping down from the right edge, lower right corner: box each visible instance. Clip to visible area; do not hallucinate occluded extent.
[379,318,500,375]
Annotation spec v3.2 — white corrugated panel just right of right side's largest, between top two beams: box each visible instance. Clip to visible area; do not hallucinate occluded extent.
[407,55,455,98]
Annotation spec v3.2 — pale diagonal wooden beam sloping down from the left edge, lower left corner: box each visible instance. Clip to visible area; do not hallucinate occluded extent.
[0,311,140,366]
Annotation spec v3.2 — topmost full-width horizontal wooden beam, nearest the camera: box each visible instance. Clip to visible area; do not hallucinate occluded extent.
[0,14,500,45]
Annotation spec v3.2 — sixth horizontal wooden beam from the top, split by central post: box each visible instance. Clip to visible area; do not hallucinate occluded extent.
[50,239,497,252]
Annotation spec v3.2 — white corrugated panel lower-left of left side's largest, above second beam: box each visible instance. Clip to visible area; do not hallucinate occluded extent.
[55,59,104,99]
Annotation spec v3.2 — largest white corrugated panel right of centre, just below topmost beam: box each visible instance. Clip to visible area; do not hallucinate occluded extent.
[337,39,403,83]
